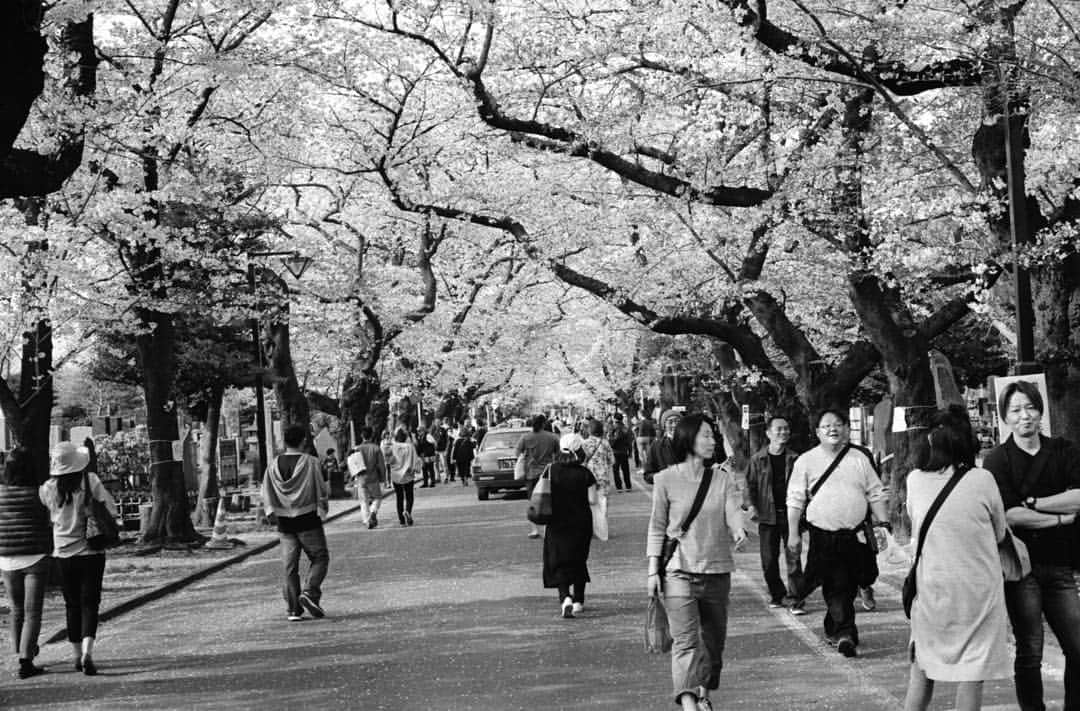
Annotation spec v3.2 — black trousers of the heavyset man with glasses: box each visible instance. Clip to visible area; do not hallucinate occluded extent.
[799,526,866,644]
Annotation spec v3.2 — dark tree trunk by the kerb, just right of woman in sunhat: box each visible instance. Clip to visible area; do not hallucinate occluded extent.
[135,309,202,542]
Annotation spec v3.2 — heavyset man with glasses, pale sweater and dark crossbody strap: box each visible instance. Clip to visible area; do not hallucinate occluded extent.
[787,410,889,657]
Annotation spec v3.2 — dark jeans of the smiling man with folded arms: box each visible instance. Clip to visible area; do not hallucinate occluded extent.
[1005,563,1080,711]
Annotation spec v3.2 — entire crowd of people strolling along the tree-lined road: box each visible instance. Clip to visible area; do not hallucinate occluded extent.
[0,380,1080,711]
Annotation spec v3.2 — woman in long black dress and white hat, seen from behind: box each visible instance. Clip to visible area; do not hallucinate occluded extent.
[543,433,597,619]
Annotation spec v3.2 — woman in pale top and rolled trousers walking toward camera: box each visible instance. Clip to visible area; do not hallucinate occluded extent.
[646,413,746,711]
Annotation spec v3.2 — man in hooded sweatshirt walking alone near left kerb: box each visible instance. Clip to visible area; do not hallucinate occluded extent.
[262,425,330,622]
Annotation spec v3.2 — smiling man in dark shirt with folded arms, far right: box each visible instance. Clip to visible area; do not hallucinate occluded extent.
[983,380,1080,711]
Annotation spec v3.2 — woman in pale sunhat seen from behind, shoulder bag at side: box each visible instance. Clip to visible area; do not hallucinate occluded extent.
[38,442,117,676]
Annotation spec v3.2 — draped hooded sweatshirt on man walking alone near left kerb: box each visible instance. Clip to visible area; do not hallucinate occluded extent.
[262,454,329,533]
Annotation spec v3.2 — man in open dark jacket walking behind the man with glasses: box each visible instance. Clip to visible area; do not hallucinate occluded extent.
[744,416,805,615]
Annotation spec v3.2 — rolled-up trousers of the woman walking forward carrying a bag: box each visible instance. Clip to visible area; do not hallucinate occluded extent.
[664,572,731,702]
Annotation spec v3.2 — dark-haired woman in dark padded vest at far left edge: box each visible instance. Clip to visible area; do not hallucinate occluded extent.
[0,446,53,679]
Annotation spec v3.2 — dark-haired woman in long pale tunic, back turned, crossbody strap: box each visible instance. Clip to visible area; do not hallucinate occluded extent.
[904,407,1010,711]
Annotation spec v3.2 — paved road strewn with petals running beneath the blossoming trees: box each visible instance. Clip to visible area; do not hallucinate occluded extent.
[0,485,1062,711]
